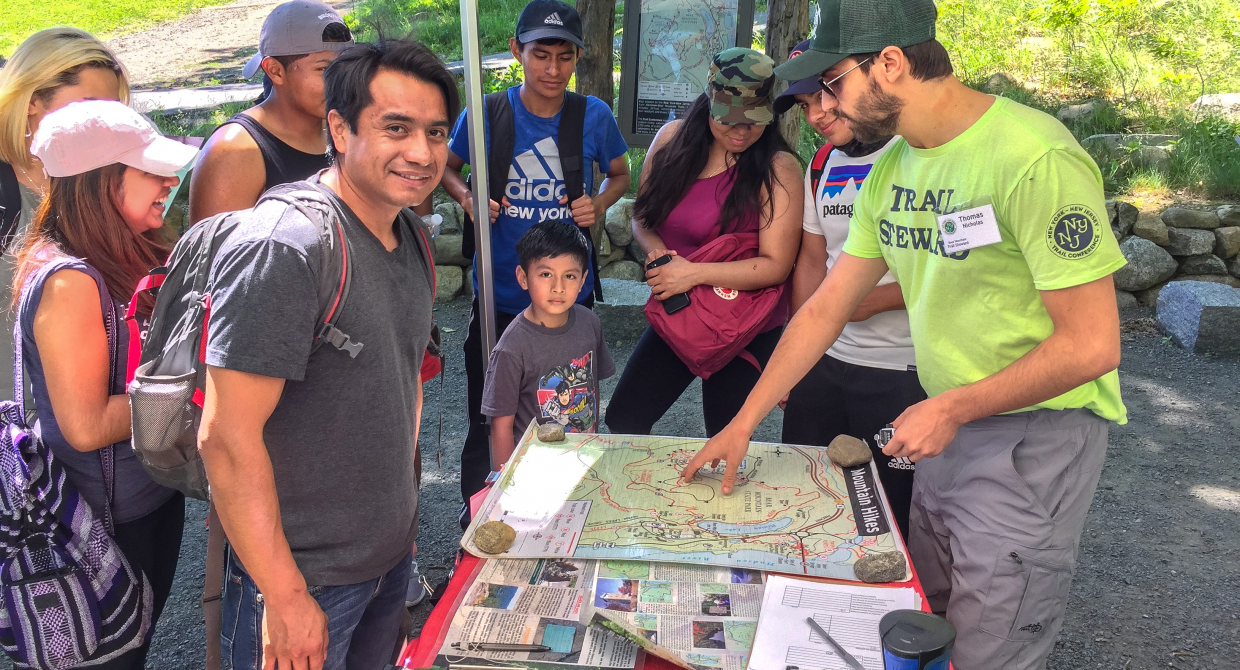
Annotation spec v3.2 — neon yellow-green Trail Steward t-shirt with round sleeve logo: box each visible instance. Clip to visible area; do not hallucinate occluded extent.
[843,98,1127,423]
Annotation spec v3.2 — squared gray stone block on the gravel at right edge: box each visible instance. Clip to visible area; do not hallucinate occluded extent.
[1158,282,1240,356]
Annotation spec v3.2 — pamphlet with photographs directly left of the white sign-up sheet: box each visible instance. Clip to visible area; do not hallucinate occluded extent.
[591,561,763,670]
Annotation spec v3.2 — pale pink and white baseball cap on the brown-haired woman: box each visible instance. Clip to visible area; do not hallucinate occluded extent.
[30,101,198,177]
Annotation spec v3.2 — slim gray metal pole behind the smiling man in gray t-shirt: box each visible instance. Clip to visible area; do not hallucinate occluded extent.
[461,0,496,361]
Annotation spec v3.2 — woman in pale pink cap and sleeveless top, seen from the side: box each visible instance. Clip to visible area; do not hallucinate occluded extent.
[12,101,195,669]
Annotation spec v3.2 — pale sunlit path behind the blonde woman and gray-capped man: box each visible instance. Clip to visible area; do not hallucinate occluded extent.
[108,0,352,88]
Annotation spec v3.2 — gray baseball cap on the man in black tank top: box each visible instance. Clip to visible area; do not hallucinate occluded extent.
[241,0,353,79]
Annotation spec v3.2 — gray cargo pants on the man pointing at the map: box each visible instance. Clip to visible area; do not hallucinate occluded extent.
[909,409,1109,670]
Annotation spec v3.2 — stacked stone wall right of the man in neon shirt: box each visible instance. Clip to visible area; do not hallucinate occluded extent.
[1106,200,1240,309]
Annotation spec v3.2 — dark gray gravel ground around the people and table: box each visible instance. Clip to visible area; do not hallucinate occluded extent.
[0,299,1240,670]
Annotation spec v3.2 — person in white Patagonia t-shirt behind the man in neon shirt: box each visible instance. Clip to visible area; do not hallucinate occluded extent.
[775,40,926,537]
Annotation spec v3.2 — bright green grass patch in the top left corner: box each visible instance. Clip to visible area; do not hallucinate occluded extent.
[0,0,228,56]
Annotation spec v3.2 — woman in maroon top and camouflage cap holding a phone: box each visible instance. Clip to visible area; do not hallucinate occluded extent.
[606,48,804,436]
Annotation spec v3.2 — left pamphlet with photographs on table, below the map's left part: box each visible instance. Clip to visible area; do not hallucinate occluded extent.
[435,558,639,670]
